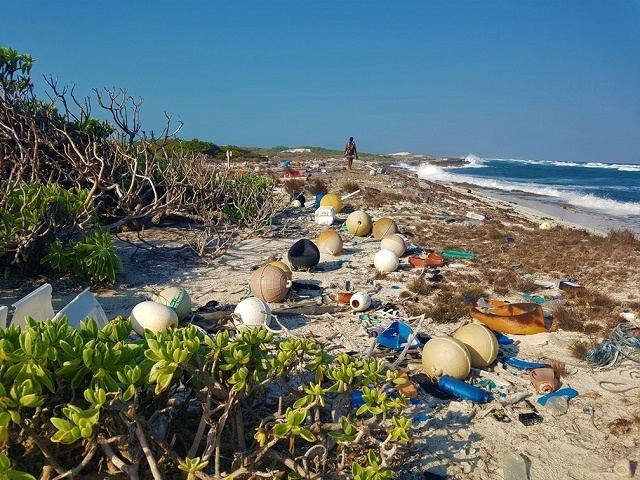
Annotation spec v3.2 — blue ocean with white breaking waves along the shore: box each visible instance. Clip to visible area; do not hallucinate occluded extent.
[394,152,640,232]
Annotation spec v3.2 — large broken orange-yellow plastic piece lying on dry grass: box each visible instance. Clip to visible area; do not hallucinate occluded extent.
[469,298,549,335]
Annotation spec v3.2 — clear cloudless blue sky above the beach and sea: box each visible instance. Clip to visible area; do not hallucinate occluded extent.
[0,0,640,163]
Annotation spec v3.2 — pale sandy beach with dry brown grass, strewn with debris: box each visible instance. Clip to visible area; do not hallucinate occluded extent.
[0,154,640,480]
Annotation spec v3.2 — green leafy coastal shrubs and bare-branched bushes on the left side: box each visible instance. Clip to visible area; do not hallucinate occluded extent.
[0,47,411,480]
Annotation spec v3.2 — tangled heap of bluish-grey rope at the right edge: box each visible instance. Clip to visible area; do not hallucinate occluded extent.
[587,323,640,370]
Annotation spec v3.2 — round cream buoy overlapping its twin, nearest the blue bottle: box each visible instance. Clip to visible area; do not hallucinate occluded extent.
[422,337,471,380]
